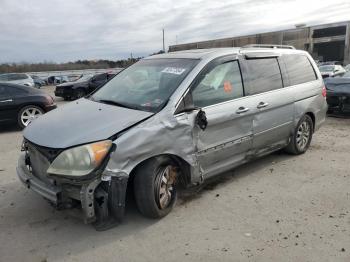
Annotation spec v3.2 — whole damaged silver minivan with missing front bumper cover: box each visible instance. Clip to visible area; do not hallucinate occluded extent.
[17,48,327,229]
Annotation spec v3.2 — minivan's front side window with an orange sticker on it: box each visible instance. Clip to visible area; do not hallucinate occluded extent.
[192,61,243,107]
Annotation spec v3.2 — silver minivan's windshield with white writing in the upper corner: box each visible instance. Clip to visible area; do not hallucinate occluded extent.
[92,58,198,112]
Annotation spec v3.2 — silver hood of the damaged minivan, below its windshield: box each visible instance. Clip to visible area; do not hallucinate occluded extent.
[23,98,153,148]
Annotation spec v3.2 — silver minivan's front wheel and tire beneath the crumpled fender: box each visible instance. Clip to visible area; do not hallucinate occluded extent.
[134,157,179,218]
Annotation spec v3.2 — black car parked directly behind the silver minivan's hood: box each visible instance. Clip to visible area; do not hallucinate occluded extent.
[55,73,115,100]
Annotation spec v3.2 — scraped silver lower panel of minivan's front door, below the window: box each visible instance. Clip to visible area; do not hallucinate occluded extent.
[195,97,257,177]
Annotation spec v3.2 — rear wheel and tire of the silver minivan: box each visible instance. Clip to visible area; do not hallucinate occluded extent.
[285,115,314,155]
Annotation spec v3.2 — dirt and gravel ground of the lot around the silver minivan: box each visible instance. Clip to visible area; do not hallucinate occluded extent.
[0,86,350,262]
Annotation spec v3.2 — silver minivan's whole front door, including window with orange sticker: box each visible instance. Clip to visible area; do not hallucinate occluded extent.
[191,57,255,178]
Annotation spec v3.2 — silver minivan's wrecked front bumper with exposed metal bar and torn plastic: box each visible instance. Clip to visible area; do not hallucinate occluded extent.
[17,153,129,230]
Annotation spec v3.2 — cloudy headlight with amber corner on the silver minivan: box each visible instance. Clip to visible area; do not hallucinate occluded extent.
[47,140,112,177]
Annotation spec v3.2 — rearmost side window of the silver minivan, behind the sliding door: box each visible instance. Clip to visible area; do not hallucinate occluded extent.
[282,55,317,86]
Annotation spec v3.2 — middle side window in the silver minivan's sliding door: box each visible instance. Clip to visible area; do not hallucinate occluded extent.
[246,58,283,95]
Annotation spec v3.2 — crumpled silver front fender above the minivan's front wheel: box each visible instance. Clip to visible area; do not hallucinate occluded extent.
[106,106,200,182]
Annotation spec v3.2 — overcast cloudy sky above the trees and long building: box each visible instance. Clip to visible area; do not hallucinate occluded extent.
[0,0,350,63]
